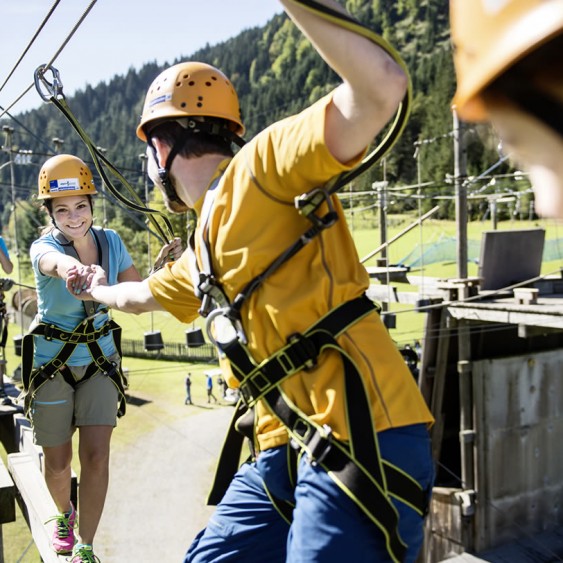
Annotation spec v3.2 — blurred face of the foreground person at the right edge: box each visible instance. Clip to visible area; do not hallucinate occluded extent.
[487,94,563,219]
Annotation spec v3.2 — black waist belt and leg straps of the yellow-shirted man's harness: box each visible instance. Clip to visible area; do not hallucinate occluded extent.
[209,296,426,561]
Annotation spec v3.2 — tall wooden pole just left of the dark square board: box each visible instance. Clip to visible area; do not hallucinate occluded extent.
[452,109,467,279]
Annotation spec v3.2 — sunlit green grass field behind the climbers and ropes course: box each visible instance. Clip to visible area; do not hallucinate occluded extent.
[0,217,563,563]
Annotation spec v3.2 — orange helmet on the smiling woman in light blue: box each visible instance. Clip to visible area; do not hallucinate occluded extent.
[37,154,98,199]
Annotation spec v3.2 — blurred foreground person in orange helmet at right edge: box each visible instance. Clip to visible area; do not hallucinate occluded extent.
[450,0,563,218]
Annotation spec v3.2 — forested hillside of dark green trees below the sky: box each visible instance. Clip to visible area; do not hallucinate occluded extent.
[0,0,524,274]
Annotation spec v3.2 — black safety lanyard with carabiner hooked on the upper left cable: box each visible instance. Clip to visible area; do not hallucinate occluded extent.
[34,65,174,243]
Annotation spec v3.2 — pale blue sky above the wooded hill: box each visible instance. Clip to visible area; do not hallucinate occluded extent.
[0,0,283,115]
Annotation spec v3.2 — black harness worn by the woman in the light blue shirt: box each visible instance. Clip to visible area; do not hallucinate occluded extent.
[22,227,128,417]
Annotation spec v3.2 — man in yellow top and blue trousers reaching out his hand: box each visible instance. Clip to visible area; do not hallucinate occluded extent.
[69,0,434,563]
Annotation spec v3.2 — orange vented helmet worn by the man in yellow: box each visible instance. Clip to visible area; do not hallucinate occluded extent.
[137,62,244,142]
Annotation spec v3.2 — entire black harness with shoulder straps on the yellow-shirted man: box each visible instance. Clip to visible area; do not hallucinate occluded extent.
[185,0,428,562]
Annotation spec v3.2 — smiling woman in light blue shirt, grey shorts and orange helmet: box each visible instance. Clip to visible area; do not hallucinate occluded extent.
[22,154,179,563]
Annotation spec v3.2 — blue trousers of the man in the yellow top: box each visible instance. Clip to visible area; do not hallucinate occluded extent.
[184,425,434,563]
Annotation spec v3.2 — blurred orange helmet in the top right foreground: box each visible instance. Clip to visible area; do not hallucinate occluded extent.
[450,0,563,121]
